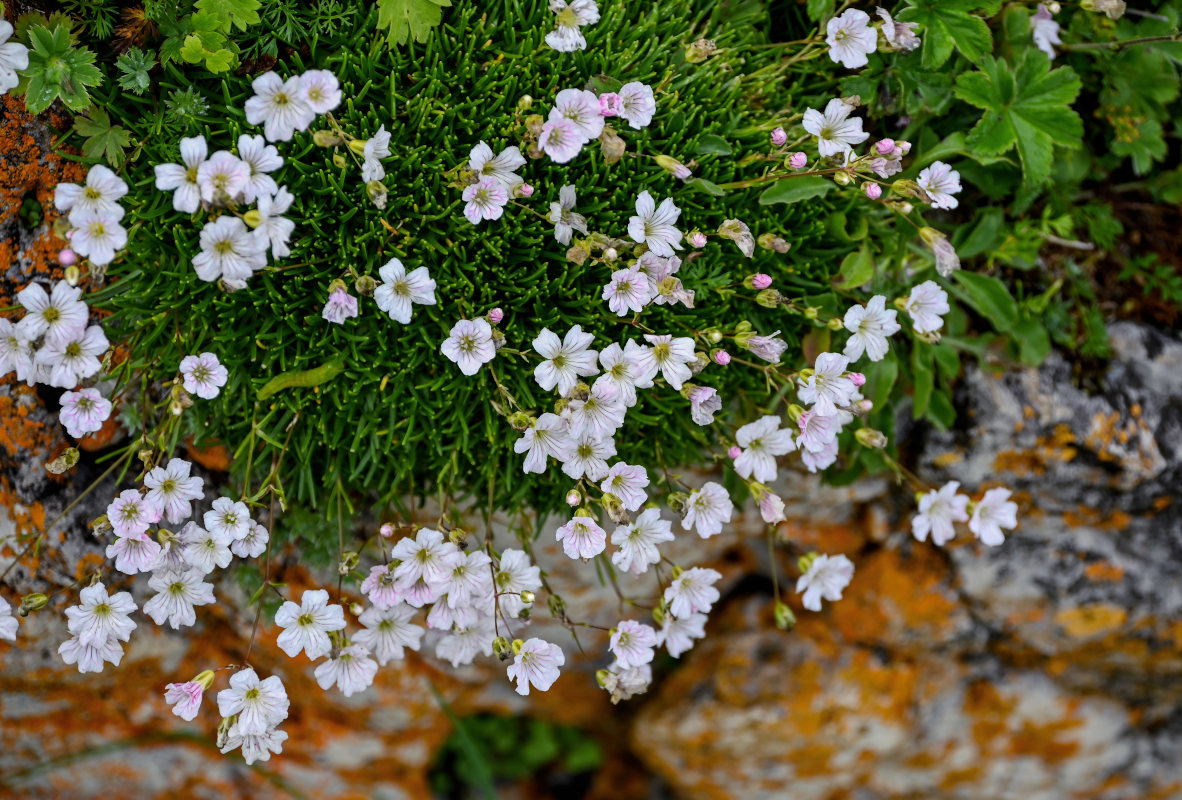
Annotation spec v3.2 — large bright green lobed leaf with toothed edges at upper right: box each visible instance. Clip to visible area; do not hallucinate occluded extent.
[955,48,1084,186]
